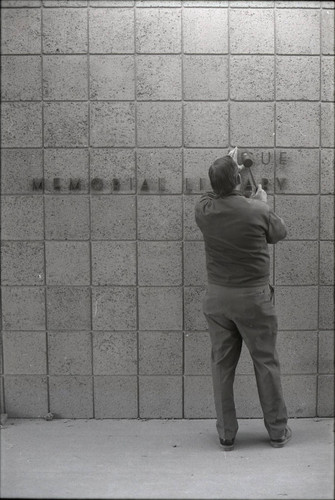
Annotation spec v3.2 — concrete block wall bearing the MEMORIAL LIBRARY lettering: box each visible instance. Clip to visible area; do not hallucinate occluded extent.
[0,0,334,418]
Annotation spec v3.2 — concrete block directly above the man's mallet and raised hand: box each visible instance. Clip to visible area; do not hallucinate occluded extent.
[230,102,274,148]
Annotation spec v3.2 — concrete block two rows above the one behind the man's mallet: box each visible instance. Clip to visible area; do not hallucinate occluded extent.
[230,55,274,101]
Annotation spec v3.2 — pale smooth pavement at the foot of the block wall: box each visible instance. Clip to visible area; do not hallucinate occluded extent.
[1,419,334,500]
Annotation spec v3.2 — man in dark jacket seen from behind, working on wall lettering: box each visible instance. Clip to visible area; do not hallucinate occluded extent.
[195,155,292,451]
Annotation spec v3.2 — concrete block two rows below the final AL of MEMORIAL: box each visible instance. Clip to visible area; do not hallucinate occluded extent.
[138,241,182,286]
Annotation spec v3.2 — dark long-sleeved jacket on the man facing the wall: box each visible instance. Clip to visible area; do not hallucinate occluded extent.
[195,191,287,287]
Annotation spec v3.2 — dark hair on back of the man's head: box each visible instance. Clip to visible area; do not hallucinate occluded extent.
[208,155,241,196]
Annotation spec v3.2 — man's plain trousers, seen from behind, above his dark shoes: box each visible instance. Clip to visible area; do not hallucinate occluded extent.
[203,284,287,439]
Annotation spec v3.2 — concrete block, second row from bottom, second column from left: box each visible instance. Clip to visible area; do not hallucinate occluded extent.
[48,331,92,375]
